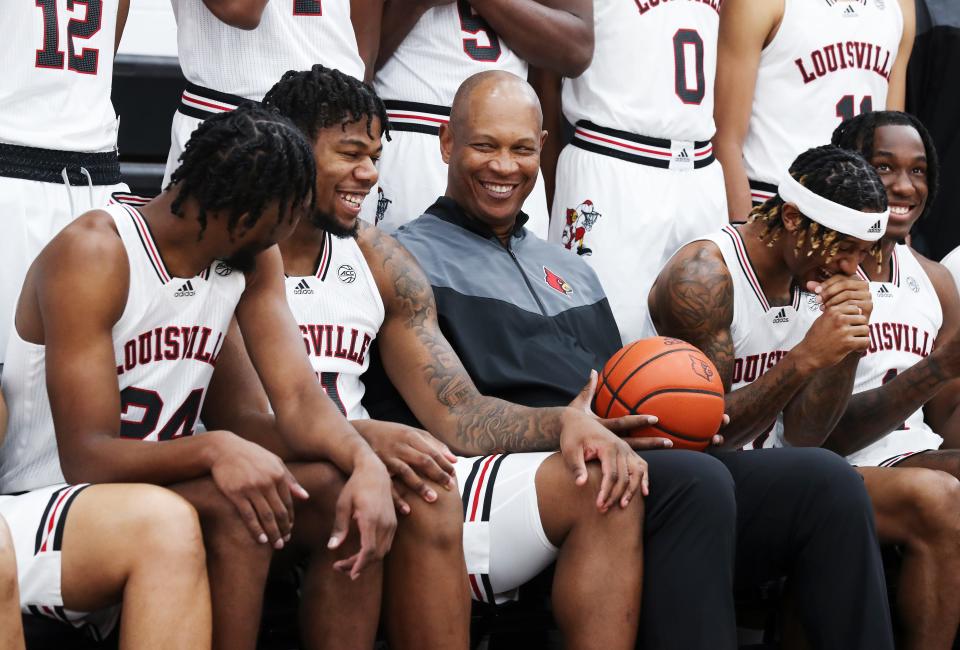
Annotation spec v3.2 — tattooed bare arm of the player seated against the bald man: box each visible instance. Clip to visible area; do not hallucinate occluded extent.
[360,228,564,455]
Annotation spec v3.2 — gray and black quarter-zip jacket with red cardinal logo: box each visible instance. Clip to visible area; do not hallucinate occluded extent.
[364,197,620,421]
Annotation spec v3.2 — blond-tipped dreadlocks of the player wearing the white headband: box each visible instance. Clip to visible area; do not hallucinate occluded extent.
[750,144,887,264]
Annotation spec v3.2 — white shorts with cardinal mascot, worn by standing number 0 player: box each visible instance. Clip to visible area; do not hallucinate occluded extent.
[550,131,727,343]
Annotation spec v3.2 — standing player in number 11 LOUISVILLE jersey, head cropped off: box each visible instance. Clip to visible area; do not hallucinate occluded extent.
[713,0,915,223]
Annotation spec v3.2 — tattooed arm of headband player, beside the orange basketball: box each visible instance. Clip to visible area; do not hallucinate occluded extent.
[648,241,812,448]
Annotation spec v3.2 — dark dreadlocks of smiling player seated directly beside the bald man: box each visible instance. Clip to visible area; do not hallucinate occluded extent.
[263,64,390,141]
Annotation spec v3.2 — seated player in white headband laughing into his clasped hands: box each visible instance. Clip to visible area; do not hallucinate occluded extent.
[650,146,960,648]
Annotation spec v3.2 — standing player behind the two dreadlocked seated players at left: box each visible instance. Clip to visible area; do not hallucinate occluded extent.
[162,0,382,187]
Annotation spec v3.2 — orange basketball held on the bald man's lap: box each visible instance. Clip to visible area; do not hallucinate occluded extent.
[593,336,723,451]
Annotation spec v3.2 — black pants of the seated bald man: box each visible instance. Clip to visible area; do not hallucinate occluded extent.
[639,449,893,650]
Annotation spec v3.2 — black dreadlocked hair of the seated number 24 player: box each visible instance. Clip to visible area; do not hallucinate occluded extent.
[167,103,316,237]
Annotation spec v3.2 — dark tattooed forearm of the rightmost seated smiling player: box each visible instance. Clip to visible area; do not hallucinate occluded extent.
[824,353,951,456]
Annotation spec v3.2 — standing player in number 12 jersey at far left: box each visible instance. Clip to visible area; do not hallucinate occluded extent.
[0,0,130,364]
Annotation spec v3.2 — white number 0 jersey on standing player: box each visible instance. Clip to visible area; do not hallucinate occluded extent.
[563,0,721,140]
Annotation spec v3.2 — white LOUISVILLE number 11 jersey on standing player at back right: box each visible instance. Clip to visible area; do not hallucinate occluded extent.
[743,0,903,183]
